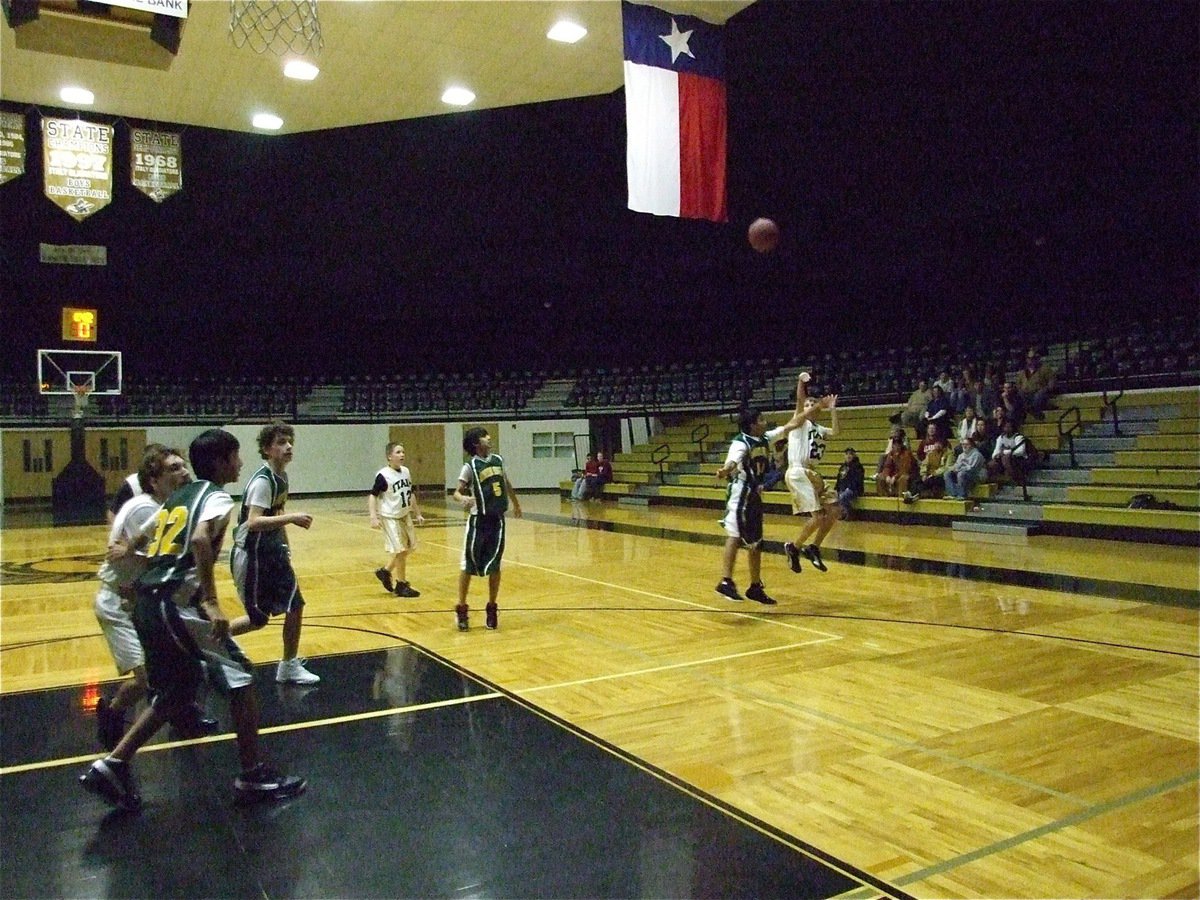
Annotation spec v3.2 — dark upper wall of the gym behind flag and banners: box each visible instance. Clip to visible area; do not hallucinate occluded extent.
[0,1,1200,374]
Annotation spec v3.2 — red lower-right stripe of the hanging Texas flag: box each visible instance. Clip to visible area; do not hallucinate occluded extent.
[679,72,728,222]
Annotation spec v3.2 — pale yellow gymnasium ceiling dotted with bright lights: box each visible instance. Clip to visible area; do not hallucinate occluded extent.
[0,0,752,133]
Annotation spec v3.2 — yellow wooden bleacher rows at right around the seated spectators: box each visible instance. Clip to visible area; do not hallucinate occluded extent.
[559,388,1200,542]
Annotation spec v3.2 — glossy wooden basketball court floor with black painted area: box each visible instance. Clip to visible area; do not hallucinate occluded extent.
[0,494,1200,900]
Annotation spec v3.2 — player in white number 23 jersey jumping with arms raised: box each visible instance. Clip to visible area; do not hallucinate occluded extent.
[784,372,841,572]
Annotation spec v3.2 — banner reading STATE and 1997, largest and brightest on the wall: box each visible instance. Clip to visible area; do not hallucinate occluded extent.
[42,119,113,222]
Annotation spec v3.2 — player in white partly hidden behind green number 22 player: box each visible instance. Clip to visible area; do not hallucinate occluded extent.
[94,444,193,750]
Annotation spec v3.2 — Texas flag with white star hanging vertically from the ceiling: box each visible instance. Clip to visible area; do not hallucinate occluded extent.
[620,2,728,222]
